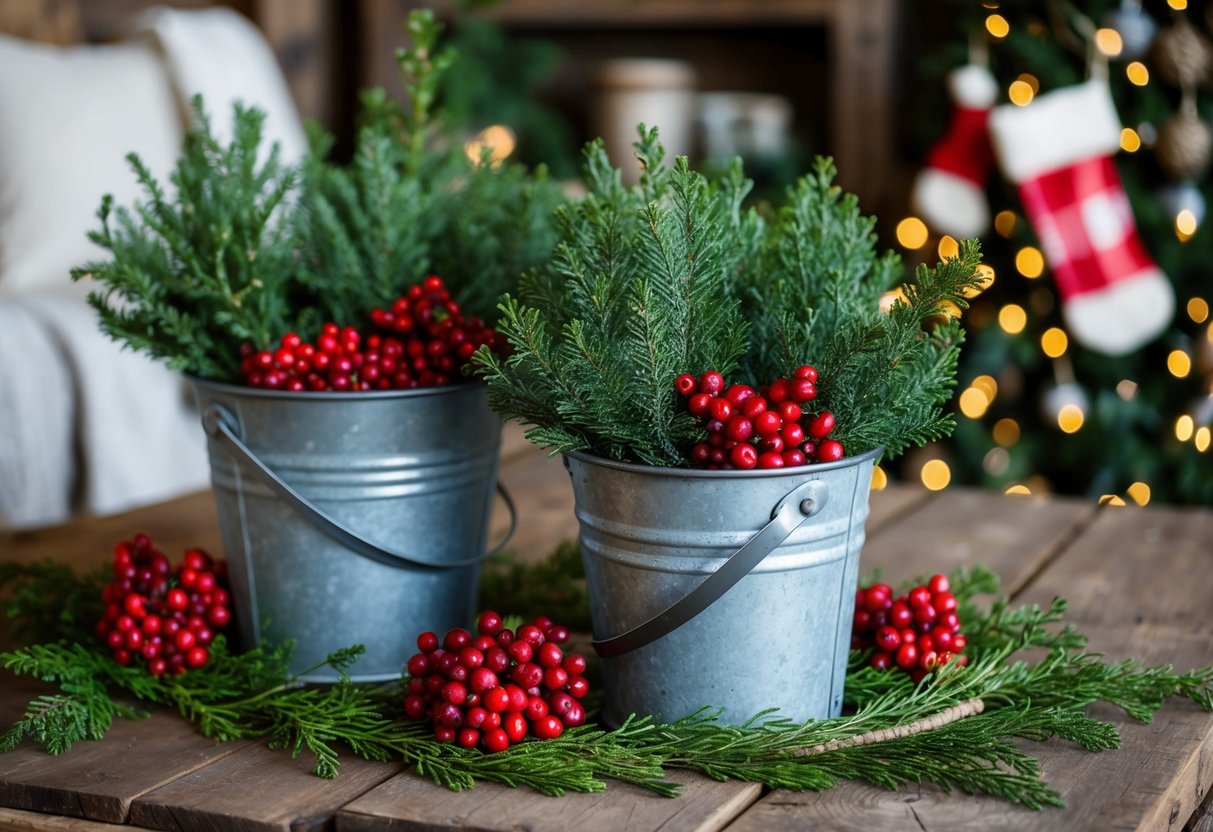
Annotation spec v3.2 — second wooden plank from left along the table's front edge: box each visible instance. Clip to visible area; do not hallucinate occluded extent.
[131,745,400,832]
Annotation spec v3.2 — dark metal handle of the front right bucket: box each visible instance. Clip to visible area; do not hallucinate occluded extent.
[591,479,830,659]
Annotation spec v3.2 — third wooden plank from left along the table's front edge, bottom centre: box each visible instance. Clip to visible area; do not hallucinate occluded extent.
[337,771,762,832]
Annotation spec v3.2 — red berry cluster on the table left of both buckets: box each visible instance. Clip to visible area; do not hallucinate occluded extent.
[96,535,232,676]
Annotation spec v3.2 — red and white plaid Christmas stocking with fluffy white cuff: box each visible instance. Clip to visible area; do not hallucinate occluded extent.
[990,80,1175,355]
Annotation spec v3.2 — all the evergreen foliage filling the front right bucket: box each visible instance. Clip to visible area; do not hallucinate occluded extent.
[475,133,980,466]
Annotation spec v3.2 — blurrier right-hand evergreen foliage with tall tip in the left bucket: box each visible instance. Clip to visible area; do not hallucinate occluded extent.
[296,10,563,321]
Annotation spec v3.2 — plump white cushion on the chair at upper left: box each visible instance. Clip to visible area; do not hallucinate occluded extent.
[0,35,183,295]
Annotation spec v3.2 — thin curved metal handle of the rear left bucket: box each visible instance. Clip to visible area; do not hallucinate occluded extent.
[203,404,518,569]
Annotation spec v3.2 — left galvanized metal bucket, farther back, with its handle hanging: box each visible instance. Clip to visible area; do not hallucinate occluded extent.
[192,380,513,682]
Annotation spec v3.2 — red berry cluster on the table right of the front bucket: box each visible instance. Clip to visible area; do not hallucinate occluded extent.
[850,575,969,682]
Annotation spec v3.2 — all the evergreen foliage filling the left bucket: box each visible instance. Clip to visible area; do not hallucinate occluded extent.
[73,11,563,381]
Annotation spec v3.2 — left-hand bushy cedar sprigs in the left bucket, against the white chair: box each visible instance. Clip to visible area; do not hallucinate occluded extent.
[72,97,295,381]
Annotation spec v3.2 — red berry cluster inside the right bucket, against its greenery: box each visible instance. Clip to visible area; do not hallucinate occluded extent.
[674,365,845,469]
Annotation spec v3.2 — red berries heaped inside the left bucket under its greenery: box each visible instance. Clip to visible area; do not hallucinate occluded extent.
[240,275,499,393]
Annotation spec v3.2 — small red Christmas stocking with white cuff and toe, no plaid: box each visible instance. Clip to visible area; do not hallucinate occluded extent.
[911,64,998,237]
